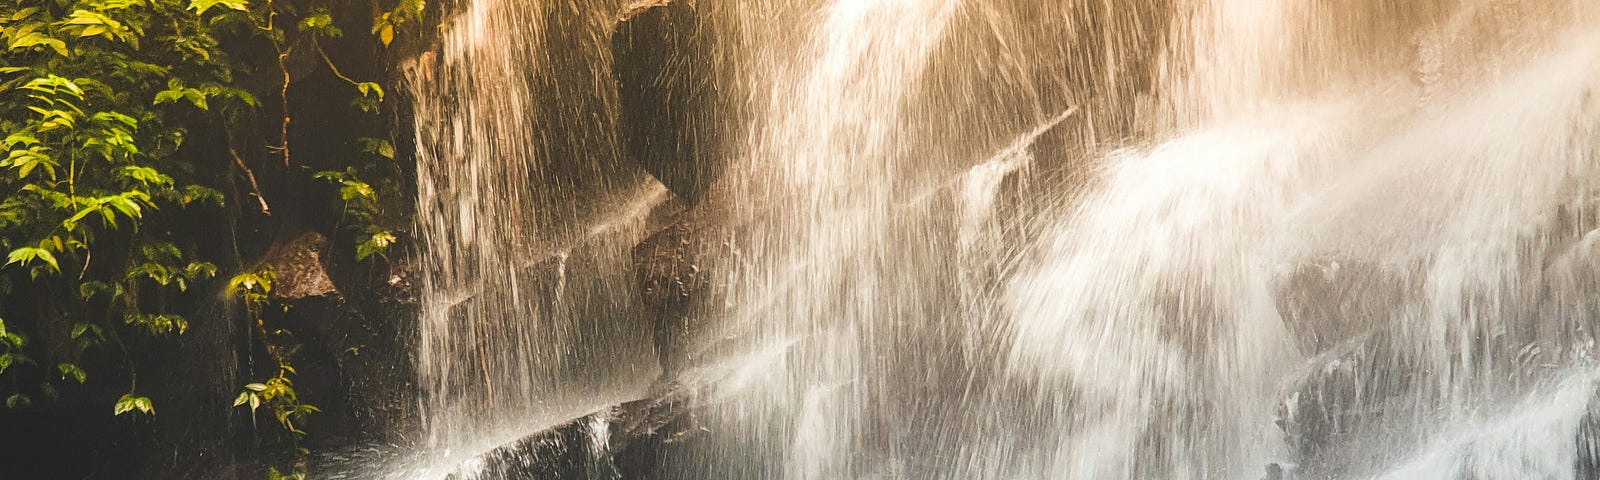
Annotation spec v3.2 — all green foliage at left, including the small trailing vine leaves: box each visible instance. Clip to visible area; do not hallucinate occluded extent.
[0,0,422,478]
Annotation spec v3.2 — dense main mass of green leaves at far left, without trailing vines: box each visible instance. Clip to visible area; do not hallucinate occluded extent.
[0,0,251,432]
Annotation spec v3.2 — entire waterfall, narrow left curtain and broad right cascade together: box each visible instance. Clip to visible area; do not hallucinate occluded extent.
[403,0,1600,478]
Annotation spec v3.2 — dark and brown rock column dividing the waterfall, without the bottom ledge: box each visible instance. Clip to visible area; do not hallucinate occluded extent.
[611,0,731,381]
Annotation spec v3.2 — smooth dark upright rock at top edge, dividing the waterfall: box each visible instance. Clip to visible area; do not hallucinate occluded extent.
[611,0,722,203]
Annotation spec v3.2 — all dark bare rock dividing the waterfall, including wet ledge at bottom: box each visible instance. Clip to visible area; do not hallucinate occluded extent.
[446,0,755,480]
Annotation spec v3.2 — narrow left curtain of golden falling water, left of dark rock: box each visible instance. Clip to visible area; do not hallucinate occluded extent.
[408,0,667,461]
